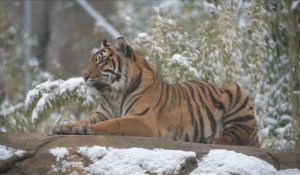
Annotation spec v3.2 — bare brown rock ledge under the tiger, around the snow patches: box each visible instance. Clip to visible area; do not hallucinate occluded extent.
[0,133,300,174]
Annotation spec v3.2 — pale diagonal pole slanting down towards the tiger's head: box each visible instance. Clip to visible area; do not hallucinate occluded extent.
[76,0,121,38]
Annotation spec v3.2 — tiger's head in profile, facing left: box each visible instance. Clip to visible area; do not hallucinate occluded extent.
[83,37,135,90]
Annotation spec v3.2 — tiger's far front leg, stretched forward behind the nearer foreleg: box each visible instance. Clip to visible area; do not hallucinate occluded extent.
[52,112,108,134]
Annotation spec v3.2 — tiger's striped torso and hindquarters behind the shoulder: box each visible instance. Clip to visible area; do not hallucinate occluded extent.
[146,81,259,146]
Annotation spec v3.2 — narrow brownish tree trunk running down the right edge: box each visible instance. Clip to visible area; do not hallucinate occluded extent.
[287,0,300,151]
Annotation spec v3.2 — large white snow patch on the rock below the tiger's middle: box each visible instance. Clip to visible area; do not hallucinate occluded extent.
[79,146,196,174]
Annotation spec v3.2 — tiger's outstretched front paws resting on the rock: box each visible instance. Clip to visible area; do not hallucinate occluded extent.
[52,124,91,135]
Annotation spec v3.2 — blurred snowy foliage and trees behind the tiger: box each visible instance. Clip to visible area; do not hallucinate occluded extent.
[0,0,300,150]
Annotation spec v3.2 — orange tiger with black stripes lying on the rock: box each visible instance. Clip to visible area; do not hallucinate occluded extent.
[52,37,259,147]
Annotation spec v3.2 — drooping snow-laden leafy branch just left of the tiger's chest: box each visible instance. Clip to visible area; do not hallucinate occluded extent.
[25,78,96,124]
